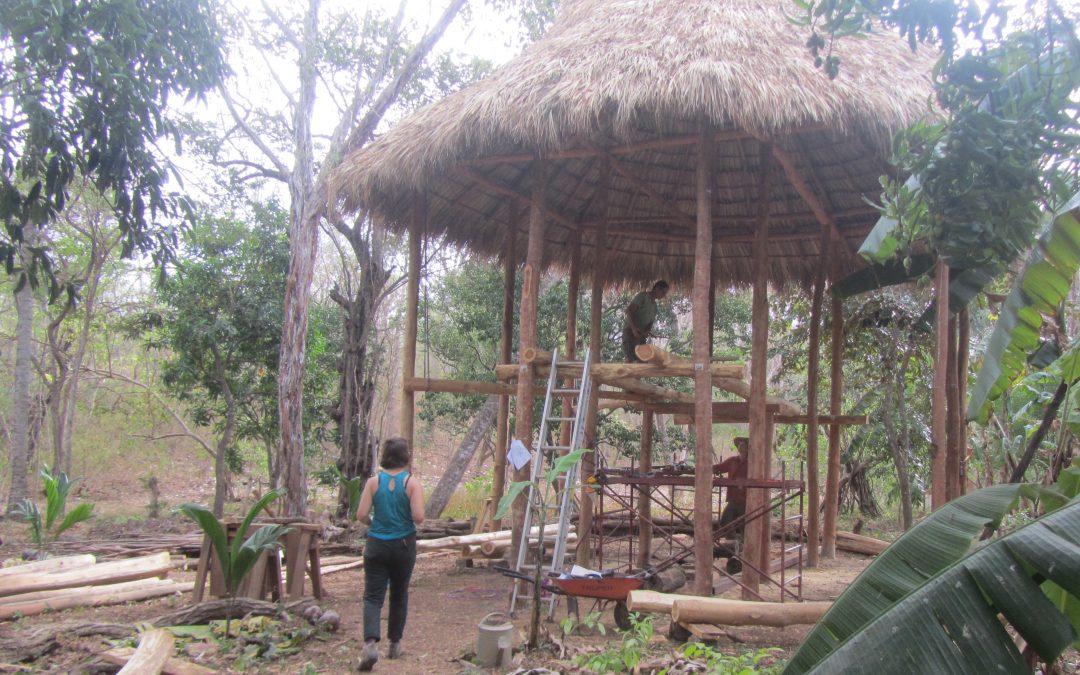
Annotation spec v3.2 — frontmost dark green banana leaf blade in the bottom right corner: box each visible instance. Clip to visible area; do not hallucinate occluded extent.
[788,500,1080,675]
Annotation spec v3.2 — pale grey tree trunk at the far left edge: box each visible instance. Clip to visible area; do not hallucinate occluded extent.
[6,275,33,513]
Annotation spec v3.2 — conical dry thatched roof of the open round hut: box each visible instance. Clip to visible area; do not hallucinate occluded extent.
[334,0,933,284]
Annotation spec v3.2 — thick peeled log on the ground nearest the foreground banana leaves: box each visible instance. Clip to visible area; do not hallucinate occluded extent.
[671,595,833,627]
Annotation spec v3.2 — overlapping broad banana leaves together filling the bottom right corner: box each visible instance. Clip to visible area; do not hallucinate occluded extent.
[784,462,1080,675]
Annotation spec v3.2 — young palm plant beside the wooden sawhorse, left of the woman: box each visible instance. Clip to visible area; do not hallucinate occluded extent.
[177,489,289,635]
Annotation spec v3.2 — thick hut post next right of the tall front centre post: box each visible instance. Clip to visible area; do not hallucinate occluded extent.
[742,141,772,599]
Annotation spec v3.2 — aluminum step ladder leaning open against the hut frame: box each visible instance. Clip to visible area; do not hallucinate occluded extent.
[510,350,592,618]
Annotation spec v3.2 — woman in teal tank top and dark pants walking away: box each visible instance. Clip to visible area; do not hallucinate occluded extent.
[356,438,423,671]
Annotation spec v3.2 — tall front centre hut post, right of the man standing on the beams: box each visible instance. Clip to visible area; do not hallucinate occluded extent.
[690,122,713,595]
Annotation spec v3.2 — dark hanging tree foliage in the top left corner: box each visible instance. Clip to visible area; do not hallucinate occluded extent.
[0,0,227,298]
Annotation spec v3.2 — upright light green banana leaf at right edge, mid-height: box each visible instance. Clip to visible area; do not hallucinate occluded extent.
[968,193,1080,421]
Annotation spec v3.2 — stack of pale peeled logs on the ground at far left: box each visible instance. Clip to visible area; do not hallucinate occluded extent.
[0,551,193,621]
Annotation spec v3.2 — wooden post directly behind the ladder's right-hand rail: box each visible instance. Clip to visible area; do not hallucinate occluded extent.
[576,161,611,567]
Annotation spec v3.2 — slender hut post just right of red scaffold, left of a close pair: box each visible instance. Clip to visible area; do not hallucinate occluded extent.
[806,228,832,567]
